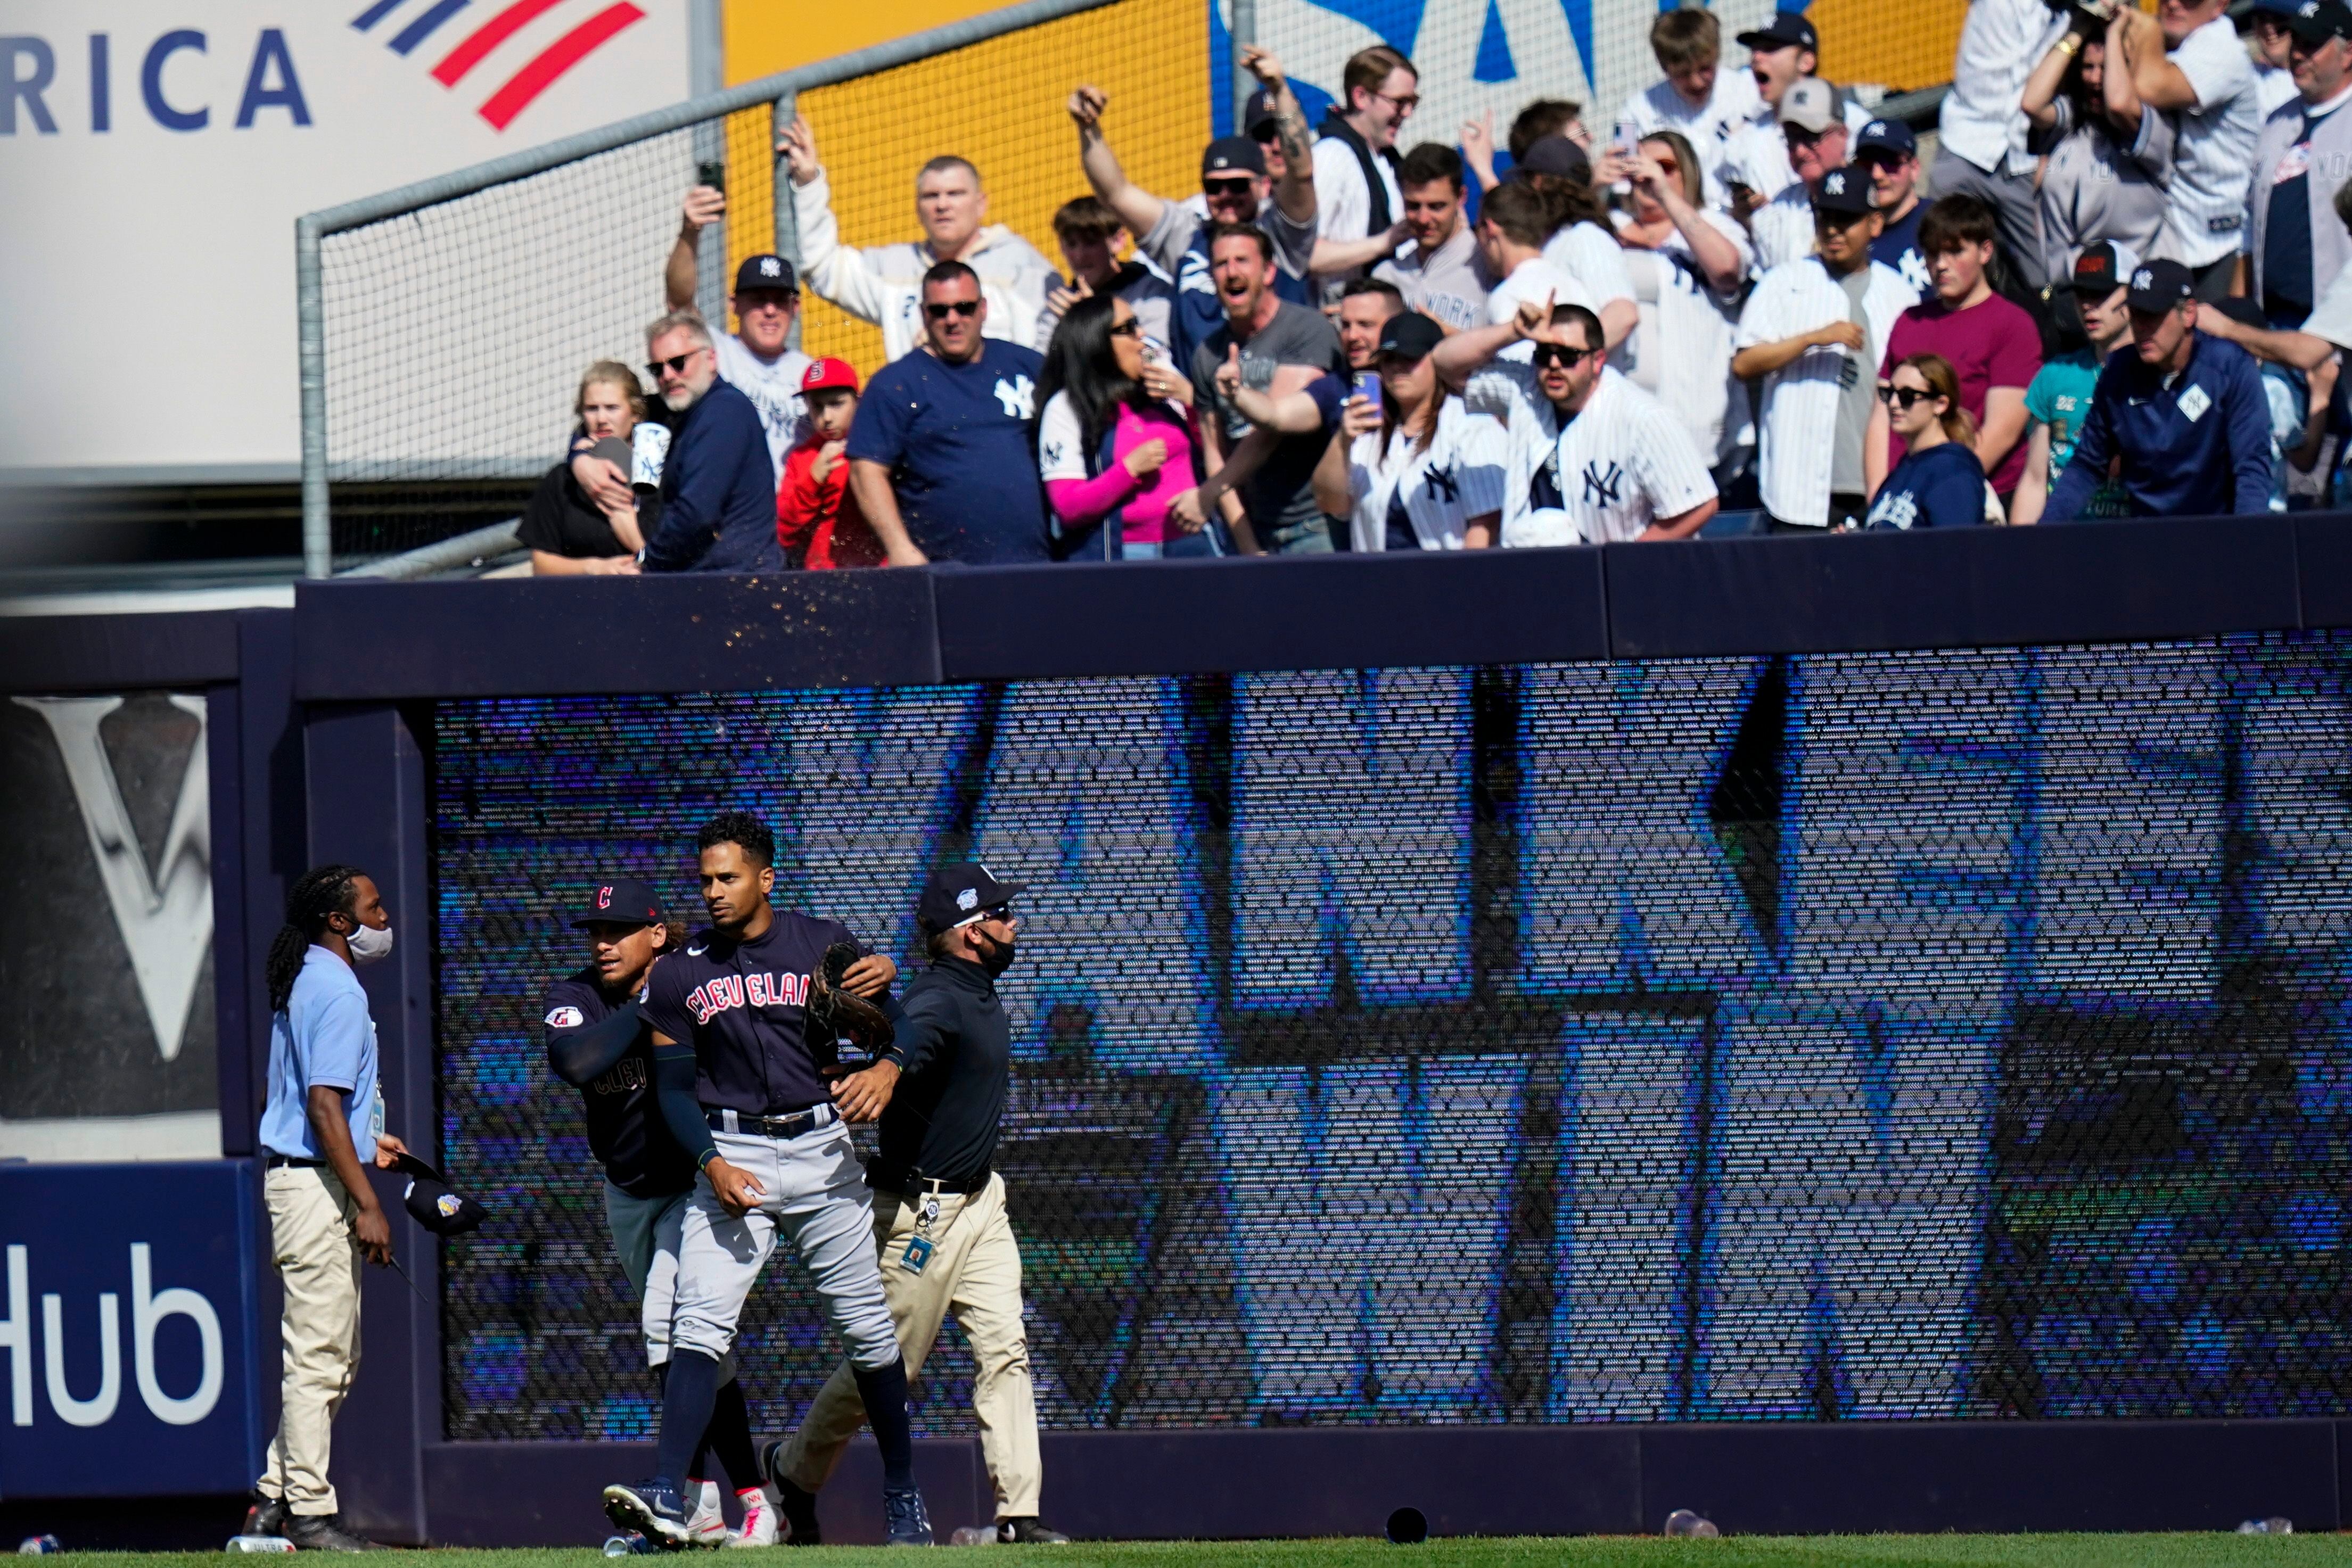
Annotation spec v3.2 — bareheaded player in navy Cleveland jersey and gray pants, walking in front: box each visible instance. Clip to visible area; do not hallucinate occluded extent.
[604,811,932,1547]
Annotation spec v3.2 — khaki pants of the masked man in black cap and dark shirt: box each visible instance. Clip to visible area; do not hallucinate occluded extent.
[783,1175,1045,1519]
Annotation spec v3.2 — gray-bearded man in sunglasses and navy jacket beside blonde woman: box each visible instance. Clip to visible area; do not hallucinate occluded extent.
[642,310,783,571]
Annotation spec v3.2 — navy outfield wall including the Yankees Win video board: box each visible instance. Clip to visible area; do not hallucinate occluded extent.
[13,517,2352,1545]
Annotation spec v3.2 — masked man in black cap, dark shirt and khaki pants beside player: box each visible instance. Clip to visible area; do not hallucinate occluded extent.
[760,863,1070,1545]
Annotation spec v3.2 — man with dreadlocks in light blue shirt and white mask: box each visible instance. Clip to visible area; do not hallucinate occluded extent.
[244,865,407,1552]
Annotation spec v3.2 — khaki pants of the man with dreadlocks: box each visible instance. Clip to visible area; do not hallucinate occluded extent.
[259,1166,360,1514]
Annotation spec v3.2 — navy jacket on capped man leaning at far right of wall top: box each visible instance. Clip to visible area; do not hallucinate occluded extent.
[2042,332,2272,522]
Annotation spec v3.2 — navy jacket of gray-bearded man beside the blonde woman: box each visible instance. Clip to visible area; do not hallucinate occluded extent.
[645,381,783,571]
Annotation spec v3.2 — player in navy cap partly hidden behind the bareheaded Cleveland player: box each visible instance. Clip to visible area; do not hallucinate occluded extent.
[541,877,776,1547]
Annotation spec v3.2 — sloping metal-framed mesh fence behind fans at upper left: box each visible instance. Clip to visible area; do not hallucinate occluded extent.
[294,0,1209,579]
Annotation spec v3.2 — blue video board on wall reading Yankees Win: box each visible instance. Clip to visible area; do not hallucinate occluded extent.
[435,635,2352,1439]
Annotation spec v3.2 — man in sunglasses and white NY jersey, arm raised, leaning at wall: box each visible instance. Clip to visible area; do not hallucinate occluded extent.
[1433,299,1717,548]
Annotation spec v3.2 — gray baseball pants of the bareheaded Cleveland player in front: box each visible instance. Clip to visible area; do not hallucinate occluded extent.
[670,1121,899,1368]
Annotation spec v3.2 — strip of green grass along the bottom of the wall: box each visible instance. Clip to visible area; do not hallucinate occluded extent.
[46,1533,2352,1568]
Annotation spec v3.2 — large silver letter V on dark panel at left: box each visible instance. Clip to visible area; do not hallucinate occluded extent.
[17,696,212,1062]
